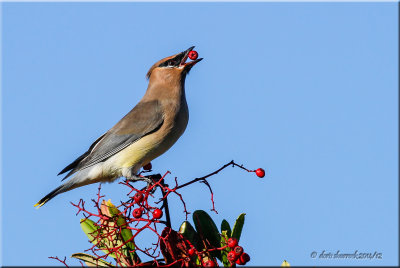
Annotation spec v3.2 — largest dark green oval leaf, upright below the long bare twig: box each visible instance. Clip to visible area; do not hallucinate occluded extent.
[193,210,221,260]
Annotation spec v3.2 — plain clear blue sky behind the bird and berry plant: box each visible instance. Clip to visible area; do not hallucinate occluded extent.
[1,3,399,266]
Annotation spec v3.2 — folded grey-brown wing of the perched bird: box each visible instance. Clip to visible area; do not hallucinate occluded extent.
[58,101,164,180]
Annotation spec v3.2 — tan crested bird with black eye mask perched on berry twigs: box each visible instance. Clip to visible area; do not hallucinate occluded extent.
[34,46,203,208]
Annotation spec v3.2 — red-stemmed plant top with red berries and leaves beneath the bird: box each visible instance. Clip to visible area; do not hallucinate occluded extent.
[56,161,265,267]
